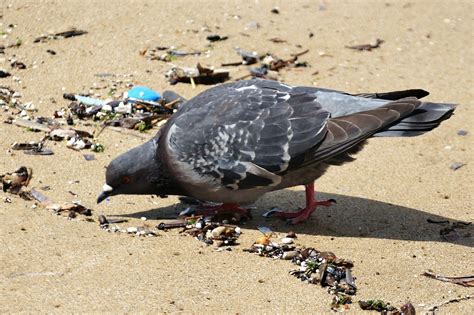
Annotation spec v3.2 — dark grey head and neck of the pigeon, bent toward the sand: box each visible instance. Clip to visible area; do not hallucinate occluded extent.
[97,139,160,203]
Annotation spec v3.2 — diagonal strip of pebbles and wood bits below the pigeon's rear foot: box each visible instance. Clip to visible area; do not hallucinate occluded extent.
[244,227,357,295]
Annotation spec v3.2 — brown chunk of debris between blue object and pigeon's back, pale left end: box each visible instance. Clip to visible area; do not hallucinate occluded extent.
[165,63,229,86]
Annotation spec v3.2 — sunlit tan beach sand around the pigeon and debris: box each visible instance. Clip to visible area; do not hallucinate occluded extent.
[0,0,474,314]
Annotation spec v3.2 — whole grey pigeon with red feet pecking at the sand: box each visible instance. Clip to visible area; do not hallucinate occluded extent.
[97,79,455,224]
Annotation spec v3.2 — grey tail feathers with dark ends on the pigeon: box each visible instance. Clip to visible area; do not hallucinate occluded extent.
[374,102,456,137]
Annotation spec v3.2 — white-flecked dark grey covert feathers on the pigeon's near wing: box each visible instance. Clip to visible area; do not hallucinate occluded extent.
[167,80,330,189]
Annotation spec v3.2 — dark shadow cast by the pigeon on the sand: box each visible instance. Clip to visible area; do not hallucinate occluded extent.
[114,190,474,247]
